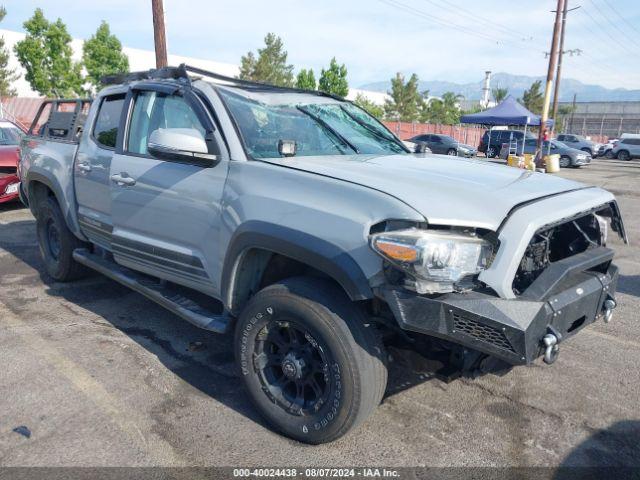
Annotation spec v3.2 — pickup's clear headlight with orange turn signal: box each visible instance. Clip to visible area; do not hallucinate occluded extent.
[369,228,493,293]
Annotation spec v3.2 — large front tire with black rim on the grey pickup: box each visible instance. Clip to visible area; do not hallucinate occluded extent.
[235,277,387,444]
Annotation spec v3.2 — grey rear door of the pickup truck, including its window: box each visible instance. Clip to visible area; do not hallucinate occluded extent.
[74,93,125,249]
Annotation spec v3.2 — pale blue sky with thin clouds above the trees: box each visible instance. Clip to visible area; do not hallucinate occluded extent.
[0,0,640,88]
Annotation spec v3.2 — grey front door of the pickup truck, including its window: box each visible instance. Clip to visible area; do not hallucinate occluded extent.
[111,86,228,297]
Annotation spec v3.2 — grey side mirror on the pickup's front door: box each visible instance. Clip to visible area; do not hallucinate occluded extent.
[147,128,218,167]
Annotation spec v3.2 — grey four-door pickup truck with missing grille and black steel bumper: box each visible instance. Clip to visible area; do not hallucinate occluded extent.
[19,65,626,443]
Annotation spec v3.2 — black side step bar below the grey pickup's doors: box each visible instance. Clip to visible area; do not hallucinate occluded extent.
[73,248,231,333]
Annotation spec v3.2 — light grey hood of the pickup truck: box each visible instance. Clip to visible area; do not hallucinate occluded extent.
[262,154,587,231]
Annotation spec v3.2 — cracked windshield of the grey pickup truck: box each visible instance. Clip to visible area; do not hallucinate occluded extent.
[218,87,407,158]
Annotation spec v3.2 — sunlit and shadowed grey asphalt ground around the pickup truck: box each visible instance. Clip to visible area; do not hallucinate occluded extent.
[0,159,640,466]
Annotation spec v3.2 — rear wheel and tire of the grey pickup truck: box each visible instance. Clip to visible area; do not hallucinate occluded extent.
[36,197,87,282]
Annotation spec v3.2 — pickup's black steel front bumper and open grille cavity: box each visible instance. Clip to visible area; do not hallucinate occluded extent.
[370,202,626,365]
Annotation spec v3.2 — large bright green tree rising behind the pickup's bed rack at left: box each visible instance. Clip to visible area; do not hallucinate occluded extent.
[14,8,85,98]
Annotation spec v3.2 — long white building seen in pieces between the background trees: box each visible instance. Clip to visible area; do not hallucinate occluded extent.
[0,29,388,105]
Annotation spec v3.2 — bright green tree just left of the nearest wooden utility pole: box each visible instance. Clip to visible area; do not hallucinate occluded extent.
[82,20,129,89]
